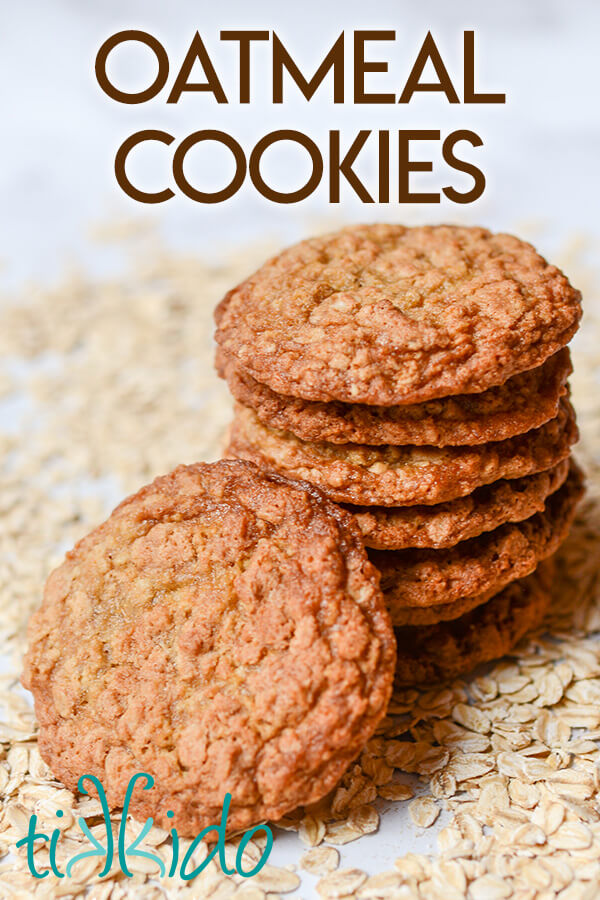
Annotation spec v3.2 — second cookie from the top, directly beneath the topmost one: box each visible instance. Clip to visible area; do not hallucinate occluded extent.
[217,347,572,447]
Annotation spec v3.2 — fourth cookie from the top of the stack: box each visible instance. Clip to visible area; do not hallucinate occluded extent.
[347,459,569,550]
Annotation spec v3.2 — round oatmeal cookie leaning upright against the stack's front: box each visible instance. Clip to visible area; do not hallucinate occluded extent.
[23,461,395,835]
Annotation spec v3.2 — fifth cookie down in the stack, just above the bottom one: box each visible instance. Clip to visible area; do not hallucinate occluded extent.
[369,464,583,623]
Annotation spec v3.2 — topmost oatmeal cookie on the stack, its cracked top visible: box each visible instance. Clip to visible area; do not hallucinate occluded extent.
[215,224,581,406]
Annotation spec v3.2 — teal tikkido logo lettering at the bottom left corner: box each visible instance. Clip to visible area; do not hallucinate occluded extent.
[16,772,273,881]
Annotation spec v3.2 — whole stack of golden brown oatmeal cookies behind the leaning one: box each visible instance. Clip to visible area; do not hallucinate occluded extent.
[216,225,583,681]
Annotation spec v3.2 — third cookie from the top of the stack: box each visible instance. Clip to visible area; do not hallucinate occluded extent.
[227,399,577,506]
